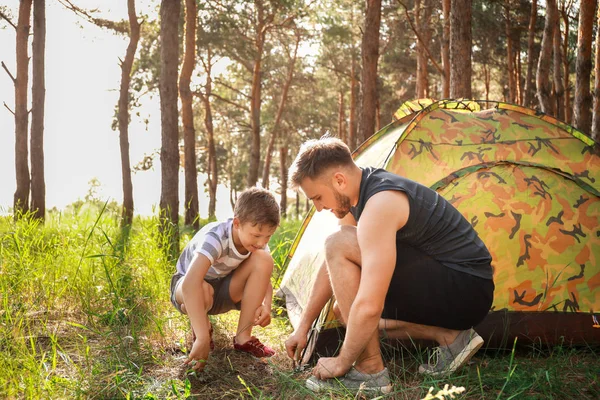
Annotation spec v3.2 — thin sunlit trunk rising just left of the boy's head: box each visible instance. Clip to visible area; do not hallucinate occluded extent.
[202,48,219,219]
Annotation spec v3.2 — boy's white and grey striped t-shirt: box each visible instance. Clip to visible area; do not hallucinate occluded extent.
[177,218,269,280]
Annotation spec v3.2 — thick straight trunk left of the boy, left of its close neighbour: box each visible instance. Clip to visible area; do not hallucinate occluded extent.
[159,0,181,257]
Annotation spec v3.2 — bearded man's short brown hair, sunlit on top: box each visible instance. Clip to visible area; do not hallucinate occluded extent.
[289,137,354,189]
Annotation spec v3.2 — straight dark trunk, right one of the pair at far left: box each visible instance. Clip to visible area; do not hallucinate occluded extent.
[30,0,46,220]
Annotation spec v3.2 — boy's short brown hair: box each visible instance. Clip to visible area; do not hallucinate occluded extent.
[233,187,279,226]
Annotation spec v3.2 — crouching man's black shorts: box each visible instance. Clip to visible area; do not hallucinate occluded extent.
[381,242,494,330]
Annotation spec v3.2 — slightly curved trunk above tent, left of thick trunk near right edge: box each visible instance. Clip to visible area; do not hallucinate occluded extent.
[536,0,557,114]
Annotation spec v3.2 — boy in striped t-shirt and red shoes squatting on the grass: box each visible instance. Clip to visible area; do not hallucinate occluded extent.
[171,188,279,371]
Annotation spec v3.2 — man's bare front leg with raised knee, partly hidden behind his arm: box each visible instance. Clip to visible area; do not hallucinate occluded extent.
[325,226,384,374]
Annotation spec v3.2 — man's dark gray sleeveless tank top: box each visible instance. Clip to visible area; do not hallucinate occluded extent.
[350,167,493,279]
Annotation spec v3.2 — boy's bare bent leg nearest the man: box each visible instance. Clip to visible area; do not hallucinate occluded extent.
[229,250,273,344]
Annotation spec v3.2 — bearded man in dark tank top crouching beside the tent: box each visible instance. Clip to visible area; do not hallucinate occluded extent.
[285,138,494,393]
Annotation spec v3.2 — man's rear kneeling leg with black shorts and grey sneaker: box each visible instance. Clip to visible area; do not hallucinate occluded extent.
[379,243,493,375]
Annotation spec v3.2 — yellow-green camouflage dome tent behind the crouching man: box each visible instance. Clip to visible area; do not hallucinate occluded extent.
[280,100,600,362]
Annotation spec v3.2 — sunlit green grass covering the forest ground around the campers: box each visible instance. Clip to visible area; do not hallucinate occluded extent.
[0,205,600,399]
